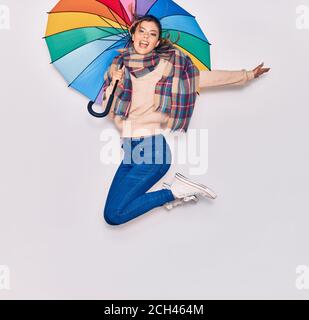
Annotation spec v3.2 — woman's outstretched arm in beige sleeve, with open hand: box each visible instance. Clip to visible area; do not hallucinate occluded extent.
[200,63,270,88]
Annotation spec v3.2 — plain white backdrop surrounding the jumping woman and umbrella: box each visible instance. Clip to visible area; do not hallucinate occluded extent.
[0,0,309,299]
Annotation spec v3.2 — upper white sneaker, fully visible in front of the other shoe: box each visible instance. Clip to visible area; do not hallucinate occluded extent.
[170,172,217,199]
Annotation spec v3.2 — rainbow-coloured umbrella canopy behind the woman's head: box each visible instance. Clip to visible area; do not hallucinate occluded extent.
[44,0,211,104]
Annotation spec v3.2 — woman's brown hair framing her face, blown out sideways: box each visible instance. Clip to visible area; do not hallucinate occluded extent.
[129,14,180,52]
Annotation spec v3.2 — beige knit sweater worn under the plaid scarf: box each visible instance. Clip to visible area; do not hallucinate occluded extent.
[102,59,254,137]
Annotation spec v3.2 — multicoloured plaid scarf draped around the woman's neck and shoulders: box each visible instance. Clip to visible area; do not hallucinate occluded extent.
[102,46,200,132]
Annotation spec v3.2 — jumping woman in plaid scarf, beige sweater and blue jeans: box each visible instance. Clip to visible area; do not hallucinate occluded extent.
[102,15,269,225]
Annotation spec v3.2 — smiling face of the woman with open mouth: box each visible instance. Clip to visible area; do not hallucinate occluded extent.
[132,21,160,54]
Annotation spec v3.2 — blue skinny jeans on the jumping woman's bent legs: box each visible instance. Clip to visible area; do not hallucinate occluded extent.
[104,134,175,225]
